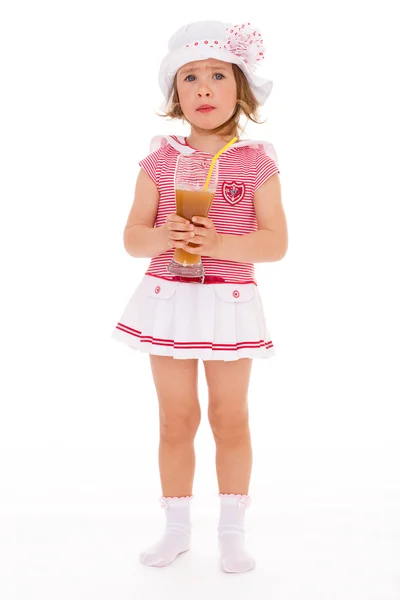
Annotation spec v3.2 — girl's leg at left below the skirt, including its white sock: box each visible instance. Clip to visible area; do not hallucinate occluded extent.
[140,355,200,567]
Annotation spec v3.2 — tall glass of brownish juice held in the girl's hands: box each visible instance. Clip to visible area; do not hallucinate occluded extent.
[167,153,218,277]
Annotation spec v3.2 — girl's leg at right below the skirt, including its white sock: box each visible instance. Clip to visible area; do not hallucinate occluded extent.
[204,358,255,573]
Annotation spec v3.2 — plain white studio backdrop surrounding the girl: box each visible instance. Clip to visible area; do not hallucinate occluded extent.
[0,0,400,600]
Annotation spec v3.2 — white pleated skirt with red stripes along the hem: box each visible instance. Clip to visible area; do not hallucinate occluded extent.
[111,275,275,361]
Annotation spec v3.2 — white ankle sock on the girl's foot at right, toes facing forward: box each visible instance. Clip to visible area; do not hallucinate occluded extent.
[218,494,256,573]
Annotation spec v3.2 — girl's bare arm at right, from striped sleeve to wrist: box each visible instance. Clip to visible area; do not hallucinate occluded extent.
[213,173,288,263]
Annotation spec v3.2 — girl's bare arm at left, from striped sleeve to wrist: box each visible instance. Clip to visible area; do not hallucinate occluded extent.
[124,169,169,258]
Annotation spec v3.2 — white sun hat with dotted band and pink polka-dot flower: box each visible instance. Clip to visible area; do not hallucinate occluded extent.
[159,21,272,106]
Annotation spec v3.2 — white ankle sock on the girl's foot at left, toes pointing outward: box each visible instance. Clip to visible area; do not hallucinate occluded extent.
[139,496,193,567]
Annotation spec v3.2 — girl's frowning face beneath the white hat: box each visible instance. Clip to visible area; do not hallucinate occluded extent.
[176,58,237,129]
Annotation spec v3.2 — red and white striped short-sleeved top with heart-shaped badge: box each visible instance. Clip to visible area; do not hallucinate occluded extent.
[139,136,280,284]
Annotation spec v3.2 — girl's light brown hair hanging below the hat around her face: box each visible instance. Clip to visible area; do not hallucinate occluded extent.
[157,64,265,138]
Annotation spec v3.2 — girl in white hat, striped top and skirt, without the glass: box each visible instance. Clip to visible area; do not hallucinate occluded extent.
[112,21,288,573]
